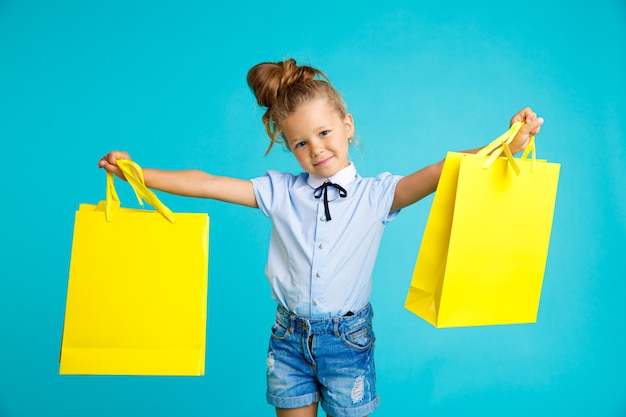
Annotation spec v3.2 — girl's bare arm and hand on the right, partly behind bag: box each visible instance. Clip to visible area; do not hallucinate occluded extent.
[390,108,543,212]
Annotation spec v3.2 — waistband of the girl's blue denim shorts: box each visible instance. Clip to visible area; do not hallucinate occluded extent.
[276,303,374,335]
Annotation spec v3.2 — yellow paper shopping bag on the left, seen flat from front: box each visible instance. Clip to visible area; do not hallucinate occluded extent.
[60,160,209,376]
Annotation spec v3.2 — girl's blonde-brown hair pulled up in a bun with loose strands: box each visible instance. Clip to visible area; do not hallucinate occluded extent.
[247,58,347,155]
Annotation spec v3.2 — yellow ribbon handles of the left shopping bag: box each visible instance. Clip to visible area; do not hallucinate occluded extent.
[104,159,175,223]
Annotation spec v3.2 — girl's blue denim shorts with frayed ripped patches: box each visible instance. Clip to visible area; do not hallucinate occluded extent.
[267,304,380,417]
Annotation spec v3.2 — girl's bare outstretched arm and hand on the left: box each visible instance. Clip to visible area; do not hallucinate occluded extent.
[98,151,258,208]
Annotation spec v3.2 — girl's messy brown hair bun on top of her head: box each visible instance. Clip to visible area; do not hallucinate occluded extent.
[247,58,327,108]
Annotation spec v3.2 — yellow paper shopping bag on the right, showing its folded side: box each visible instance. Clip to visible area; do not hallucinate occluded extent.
[405,123,560,327]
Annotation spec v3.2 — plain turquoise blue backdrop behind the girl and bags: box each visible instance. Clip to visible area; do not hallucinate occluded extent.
[0,0,626,417]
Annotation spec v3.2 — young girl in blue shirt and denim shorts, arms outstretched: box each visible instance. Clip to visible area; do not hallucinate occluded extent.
[99,59,543,417]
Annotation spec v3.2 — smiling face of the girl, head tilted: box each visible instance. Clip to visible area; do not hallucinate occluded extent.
[283,99,354,178]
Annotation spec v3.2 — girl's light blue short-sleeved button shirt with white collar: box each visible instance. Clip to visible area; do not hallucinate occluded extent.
[252,163,402,318]
